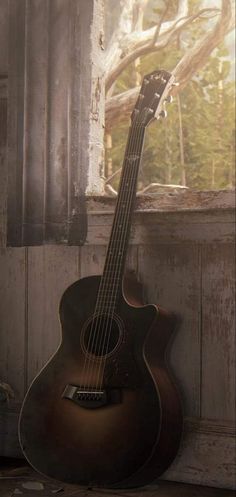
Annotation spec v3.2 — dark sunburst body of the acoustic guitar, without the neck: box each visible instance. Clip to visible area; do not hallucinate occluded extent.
[19,276,182,488]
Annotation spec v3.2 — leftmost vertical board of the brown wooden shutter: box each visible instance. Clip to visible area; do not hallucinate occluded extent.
[7,0,25,246]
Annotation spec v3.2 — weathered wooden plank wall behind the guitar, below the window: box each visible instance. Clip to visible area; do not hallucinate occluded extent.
[0,194,235,488]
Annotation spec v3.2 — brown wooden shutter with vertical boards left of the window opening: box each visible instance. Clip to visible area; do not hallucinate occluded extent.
[7,0,102,246]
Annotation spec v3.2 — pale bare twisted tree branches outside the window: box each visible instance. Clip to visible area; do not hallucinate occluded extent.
[104,0,234,128]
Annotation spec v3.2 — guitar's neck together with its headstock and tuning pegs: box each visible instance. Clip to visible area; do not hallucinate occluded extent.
[95,69,174,313]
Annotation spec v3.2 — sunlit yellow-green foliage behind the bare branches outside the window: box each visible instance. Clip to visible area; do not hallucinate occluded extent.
[106,2,235,190]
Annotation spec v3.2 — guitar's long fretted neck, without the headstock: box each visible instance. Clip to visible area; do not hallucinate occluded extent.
[96,125,145,311]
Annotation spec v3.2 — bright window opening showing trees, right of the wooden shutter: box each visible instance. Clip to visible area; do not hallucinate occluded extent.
[105,0,235,193]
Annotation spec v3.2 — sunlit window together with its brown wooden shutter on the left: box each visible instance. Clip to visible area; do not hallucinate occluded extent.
[4,0,234,246]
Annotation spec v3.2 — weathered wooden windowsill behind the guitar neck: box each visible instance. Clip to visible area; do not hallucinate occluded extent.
[86,190,235,246]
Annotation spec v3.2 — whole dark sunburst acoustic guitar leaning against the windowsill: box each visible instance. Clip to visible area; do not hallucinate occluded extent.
[19,70,182,488]
